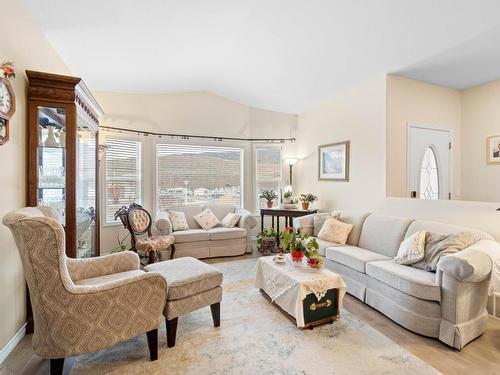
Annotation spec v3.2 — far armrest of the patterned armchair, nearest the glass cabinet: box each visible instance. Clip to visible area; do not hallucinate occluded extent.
[66,251,140,282]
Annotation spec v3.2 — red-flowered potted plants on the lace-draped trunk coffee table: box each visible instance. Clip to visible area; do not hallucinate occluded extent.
[280,227,324,269]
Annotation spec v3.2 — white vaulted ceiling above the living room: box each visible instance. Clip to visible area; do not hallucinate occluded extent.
[24,0,500,113]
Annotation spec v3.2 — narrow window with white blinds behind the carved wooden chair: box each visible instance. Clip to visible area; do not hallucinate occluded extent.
[105,138,142,223]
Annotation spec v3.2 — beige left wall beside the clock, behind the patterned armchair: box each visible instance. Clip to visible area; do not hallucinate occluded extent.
[0,0,69,349]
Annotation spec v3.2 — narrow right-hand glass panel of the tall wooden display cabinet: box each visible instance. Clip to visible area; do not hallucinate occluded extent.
[76,119,97,258]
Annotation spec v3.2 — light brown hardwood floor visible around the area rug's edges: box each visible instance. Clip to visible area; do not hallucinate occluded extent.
[0,255,500,375]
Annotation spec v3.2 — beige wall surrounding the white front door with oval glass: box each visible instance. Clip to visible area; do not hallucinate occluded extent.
[387,75,462,199]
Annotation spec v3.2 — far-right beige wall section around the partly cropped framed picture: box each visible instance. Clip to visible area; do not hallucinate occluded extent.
[462,80,500,202]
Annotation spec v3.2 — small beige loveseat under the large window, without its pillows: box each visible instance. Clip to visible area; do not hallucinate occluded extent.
[155,204,257,259]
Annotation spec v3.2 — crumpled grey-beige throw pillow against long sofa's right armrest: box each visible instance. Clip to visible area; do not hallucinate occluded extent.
[412,232,477,272]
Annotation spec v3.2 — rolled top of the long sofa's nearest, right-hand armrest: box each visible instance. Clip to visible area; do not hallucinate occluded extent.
[437,246,493,282]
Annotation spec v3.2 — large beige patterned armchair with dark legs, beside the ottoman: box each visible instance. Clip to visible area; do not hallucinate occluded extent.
[3,207,167,374]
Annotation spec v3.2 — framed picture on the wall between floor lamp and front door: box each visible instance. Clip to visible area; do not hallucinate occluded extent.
[318,141,350,181]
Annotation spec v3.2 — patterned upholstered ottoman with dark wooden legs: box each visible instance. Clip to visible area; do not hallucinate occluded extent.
[145,257,222,348]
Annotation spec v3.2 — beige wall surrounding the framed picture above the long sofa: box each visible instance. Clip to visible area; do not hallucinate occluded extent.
[295,76,386,211]
